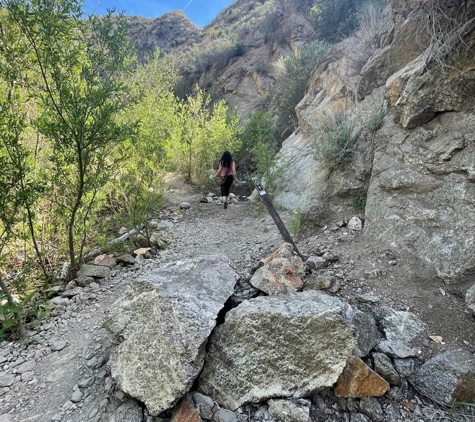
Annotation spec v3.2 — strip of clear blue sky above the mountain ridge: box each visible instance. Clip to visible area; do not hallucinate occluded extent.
[84,0,233,28]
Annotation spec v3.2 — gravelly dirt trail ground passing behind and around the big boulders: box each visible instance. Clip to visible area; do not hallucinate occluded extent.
[0,177,475,422]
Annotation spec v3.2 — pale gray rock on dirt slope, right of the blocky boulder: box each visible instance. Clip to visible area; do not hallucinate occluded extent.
[381,307,427,345]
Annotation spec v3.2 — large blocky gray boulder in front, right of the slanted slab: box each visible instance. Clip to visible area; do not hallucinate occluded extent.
[199,291,356,410]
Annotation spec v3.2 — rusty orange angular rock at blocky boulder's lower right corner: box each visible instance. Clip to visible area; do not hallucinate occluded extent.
[335,356,389,397]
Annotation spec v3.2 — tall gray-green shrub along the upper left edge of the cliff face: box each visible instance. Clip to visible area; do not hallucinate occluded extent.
[270,41,328,138]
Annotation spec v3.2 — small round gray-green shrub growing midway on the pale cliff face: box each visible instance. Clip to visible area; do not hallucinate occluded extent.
[315,112,357,168]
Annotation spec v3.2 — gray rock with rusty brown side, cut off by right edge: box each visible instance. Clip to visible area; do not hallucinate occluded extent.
[410,351,475,405]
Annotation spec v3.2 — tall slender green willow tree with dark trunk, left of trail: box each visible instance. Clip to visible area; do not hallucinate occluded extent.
[2,0,133,277]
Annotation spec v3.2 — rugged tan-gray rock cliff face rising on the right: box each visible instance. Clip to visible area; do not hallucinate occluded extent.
[276,1,475,282]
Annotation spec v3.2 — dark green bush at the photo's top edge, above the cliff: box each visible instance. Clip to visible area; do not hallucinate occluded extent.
[310,0,374,42]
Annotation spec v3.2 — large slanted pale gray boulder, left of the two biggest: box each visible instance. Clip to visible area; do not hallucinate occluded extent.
[105,255,237,415]
